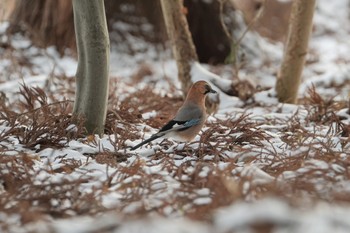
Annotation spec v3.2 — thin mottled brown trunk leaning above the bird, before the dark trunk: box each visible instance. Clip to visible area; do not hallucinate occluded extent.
[160,0,198,95]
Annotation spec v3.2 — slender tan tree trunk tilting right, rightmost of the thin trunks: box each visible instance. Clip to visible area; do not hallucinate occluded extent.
[276,0,316,103]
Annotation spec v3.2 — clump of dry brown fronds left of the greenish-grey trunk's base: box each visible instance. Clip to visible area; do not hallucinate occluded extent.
[0,85,84,151]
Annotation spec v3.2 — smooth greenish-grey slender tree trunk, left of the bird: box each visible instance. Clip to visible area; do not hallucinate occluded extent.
[73,0,110,135]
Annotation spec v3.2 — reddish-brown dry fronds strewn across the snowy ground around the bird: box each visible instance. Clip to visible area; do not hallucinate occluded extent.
[0,78,350,232]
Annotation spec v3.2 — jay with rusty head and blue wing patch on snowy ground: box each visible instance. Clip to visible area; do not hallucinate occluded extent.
[131,81,217,150]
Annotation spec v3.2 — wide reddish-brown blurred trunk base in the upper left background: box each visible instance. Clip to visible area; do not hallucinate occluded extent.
[6,0,75,54]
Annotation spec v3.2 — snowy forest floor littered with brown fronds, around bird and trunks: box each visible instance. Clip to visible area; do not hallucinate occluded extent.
[0,1,350,233]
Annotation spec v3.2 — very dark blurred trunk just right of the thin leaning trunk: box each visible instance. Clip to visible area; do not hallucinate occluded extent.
[184,0,234,64]
